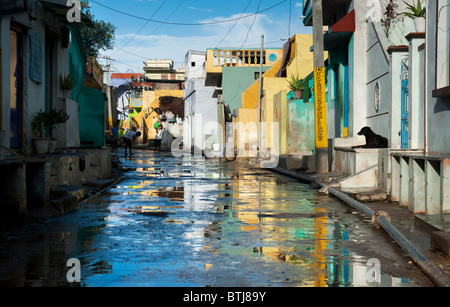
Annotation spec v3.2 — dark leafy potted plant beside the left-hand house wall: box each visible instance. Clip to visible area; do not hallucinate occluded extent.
[31,110,69,138]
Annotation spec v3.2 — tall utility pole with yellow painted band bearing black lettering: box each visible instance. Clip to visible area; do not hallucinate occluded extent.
[312,0,328,174]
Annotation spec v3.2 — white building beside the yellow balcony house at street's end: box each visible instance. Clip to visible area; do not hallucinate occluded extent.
[183,50,220,155]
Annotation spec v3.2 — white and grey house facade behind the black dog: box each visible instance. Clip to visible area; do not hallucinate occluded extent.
[303,0,450,214]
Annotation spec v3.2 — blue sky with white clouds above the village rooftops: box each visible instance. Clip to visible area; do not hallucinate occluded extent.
[90,0,312,72]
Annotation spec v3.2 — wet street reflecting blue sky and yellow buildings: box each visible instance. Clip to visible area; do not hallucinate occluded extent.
[0,150,432,287]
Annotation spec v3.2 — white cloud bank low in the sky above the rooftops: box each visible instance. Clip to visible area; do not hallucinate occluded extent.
[106,14,310,72]
